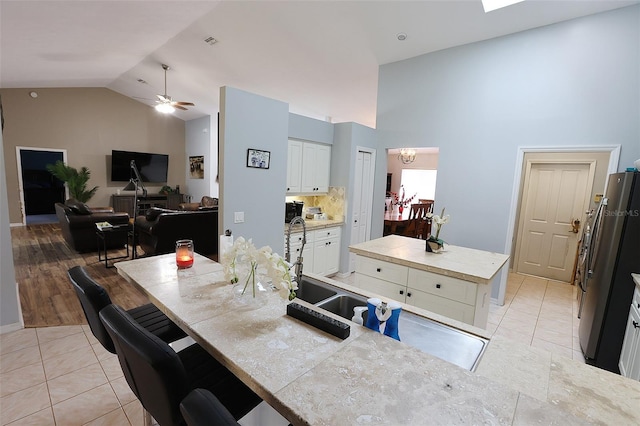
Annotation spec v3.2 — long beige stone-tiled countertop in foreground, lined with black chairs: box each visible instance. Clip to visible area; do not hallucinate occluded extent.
[116,254,640,425]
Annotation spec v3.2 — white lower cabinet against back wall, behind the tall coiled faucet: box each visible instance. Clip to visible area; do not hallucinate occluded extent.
[285,226,341,276]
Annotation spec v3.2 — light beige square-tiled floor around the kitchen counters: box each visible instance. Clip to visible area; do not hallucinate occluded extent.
[0,274,584,426]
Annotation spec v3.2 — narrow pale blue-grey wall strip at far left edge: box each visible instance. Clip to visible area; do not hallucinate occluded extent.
[0,103,23,333]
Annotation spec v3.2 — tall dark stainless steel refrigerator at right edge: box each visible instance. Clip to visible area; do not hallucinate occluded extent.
[579,172,640,373]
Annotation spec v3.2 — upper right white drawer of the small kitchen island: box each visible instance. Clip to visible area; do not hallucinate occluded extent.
[407,269,478,305]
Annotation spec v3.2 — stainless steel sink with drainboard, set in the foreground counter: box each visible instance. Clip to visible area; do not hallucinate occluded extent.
[296,277,488,371]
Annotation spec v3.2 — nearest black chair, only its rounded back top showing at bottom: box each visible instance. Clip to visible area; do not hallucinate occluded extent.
[180,388,238,426]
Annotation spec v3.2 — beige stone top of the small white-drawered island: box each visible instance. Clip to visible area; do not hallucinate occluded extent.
[349,235,509,284]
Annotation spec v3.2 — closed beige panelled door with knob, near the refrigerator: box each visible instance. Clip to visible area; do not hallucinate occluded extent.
[516,160,595,282]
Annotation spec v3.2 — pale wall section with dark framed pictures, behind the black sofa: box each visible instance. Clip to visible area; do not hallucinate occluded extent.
[182,115,218,203]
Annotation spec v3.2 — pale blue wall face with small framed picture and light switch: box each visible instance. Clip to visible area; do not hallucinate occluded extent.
[219,87,289,254]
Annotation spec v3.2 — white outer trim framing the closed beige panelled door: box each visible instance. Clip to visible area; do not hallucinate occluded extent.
[496,145,621,305]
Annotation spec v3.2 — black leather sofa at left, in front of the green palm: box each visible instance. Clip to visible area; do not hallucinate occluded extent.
[55,199,129,253]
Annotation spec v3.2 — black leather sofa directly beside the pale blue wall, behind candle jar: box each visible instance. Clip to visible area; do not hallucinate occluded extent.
[135,207,219,257]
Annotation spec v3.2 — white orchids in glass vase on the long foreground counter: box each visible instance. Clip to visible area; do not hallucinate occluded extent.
[222,237,298,300]
